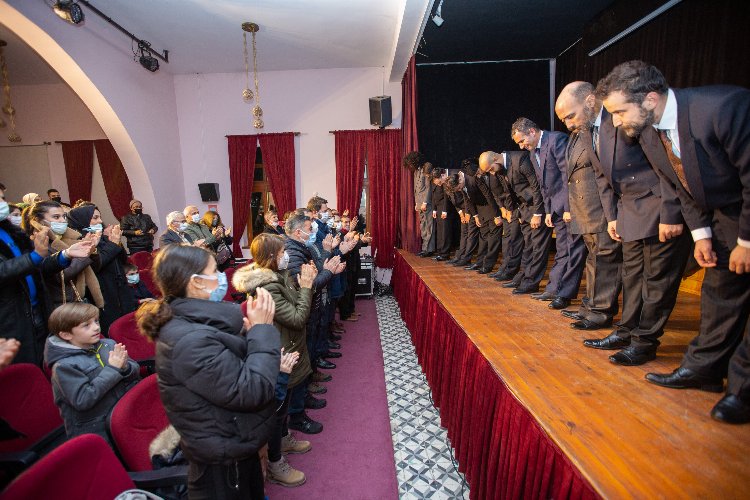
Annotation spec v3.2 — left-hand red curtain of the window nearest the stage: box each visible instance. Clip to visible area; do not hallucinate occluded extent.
[334,130,367,217]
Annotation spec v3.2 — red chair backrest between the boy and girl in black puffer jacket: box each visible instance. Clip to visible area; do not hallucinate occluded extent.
[109,374,169,471]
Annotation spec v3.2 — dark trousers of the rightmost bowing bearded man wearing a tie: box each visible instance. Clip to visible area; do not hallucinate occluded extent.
[682,206,750,390]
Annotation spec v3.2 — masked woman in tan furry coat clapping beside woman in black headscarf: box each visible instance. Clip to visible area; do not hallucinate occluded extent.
[21,201,104,309]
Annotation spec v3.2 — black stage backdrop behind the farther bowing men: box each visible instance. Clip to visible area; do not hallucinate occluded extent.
[417,61,550,169]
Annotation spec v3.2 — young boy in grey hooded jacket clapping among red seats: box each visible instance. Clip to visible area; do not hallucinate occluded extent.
[44,302,139,442]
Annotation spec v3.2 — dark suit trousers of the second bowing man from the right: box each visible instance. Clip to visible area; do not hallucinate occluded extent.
[615,231,692,349]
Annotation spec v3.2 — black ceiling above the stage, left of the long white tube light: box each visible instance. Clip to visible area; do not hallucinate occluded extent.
[416,0,614,63]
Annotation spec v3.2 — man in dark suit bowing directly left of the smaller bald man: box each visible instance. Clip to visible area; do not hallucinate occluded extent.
[462,160,500,274]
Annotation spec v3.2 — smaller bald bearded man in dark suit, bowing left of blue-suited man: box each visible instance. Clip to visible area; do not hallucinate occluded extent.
[479,151,551,295]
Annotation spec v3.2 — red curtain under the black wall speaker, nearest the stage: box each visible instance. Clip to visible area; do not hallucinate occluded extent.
[363,129,403,268]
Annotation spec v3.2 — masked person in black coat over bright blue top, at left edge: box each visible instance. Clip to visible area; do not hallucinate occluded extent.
[0,190,92,365]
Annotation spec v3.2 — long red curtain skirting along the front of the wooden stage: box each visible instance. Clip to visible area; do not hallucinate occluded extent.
[391,254,598,499]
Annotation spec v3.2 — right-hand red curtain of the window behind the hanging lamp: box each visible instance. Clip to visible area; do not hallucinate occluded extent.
[258,132,297,218]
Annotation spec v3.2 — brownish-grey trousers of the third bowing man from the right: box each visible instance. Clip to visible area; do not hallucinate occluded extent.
[578,231,622,325]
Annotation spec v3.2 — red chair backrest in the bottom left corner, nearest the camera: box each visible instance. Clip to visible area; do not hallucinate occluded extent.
[0,434,135,500]
